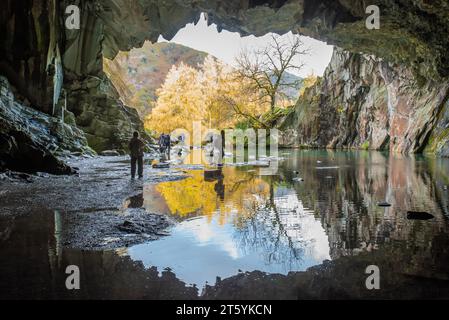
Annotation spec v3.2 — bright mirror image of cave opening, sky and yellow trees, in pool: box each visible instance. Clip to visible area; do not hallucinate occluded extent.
[128,167,330,287]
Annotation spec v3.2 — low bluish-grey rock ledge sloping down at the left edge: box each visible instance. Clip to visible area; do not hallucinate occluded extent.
[0,77,94,174]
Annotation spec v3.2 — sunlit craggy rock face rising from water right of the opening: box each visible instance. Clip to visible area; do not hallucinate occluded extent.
[279,49,449,155]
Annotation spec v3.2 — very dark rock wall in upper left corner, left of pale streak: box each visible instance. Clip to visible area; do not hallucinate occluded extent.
[0,0,59,112]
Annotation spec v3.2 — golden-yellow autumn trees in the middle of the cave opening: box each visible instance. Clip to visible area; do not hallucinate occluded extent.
[145,56,269,132]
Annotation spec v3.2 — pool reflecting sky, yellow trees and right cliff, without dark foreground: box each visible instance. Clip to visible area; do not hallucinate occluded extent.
[128,151,449,288]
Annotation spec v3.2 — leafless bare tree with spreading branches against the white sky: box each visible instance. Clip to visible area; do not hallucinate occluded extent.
[236,34,309,111]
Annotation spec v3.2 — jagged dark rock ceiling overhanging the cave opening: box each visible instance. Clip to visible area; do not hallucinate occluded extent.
[98,0,449,78]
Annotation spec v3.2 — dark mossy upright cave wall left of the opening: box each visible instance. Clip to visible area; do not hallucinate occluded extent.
[0,0,143,158]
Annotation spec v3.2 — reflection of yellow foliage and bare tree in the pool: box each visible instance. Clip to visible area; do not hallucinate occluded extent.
[156,167,304,270]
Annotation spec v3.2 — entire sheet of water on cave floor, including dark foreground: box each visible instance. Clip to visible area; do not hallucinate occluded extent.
[0,150,449,299]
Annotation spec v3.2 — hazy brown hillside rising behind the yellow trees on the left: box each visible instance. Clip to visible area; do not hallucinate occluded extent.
[104,42,300,118]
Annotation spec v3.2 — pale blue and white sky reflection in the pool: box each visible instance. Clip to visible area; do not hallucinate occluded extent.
[129,182,329,287]
